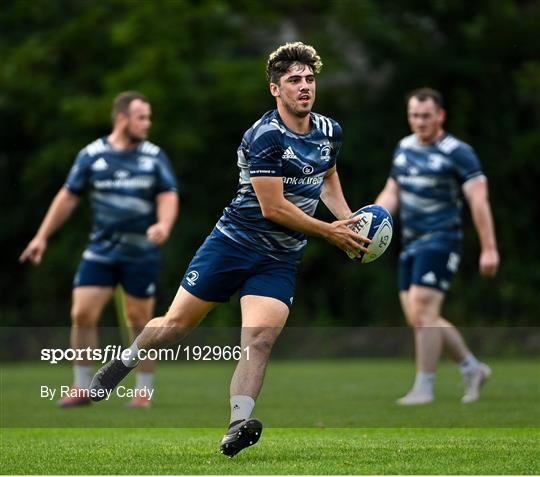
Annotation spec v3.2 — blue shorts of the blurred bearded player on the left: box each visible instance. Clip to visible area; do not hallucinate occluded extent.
[73,259,159,298]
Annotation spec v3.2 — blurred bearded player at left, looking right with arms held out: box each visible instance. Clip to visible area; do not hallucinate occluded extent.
[19,91,178,407]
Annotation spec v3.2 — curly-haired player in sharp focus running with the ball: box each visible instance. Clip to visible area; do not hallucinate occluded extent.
[87,42,370,457]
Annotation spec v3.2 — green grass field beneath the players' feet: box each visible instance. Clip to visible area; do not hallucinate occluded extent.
[0,360,540,475]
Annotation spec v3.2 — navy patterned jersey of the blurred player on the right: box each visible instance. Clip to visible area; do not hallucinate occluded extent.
[390,133,483,253]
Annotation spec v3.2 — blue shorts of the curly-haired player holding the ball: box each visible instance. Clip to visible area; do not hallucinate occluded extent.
[181,229,298,309]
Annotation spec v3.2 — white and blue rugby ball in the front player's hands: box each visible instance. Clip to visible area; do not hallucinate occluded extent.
[347,204,393,263]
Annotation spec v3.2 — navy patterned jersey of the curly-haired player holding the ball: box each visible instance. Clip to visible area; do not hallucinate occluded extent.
[216,110,341,262]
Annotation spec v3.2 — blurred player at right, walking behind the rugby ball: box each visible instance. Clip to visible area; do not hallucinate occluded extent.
[376,88,499,405]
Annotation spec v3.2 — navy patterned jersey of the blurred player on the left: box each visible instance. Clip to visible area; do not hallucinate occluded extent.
[64,137,177,263]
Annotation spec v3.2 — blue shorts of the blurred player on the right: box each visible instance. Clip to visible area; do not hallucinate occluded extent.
[399,250,461,292]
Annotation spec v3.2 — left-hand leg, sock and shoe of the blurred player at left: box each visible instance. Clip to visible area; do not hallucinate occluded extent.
[58,286,113,407]
